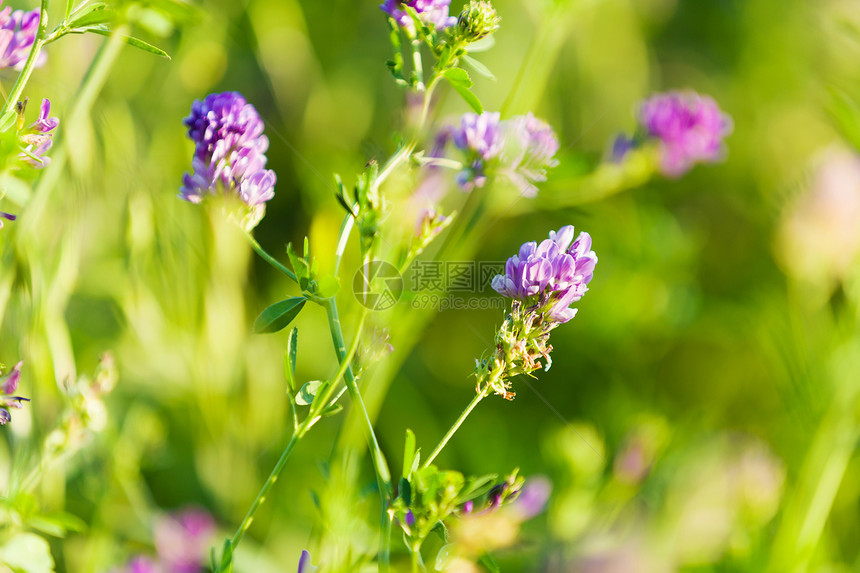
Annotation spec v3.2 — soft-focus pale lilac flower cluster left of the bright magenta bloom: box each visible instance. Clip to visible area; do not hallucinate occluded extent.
[444,112,559,197]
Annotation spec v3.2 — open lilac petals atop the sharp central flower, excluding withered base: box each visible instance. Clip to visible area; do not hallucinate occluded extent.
[492,225,597,323]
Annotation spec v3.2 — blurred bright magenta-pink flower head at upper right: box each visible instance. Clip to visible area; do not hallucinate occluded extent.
[639,92,732,177]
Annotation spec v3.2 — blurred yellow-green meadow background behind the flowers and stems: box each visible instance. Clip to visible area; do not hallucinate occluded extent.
[0,0,860,573]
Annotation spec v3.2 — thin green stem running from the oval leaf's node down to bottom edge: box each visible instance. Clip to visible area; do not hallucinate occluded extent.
[323,298,392,572]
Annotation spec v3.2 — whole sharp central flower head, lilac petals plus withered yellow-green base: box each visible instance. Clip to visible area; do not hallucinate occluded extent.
[475,225,597,400]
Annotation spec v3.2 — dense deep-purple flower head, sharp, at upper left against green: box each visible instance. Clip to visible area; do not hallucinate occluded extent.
[179,92,276,221]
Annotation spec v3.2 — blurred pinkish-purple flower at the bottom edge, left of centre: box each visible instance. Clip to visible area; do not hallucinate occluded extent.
[155,508,215,573]
